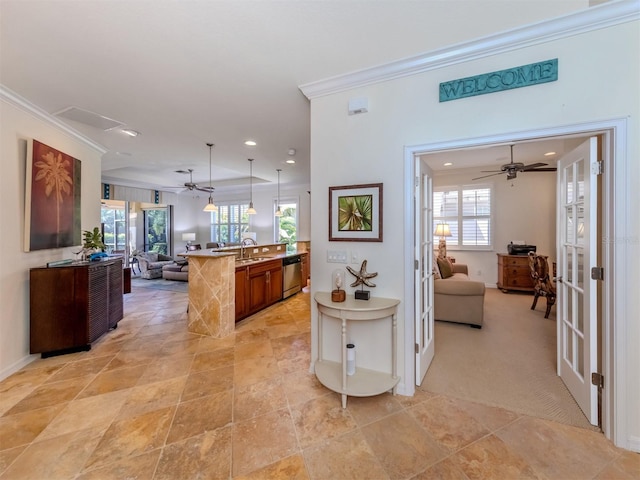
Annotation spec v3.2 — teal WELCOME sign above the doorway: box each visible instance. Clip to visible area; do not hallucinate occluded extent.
[440,58,558,102]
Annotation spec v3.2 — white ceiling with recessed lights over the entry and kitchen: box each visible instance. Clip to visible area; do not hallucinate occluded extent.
[0,0,588,191]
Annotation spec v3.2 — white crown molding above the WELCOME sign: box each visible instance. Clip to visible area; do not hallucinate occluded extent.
[298,0,640,100]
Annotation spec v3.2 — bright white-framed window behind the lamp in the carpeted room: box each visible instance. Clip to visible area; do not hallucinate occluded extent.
[433,186,493,250]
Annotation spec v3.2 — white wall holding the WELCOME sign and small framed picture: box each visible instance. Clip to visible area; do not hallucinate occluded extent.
[311,19,640,449]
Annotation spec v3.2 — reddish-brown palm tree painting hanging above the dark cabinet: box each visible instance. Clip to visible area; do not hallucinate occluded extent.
[24,140,82,252]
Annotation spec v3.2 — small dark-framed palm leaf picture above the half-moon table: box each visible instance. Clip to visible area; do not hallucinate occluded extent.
[329,183,382,242]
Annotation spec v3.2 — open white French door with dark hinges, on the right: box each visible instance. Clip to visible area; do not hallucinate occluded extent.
[556,137,598,425]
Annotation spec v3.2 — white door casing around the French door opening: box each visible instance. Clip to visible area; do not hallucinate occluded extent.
[405,120,628,446]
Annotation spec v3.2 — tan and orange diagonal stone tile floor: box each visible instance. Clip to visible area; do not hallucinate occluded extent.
[0,288,640,480]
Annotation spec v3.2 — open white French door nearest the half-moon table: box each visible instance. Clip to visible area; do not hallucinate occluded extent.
[414,156,435,385]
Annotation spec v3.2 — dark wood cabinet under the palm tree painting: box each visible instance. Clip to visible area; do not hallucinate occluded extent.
[29,258,123,357]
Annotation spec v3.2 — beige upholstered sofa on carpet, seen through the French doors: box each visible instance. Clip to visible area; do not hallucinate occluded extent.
[433,259,485,328]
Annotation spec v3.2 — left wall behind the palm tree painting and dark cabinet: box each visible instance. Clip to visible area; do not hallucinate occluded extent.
[0,95,102,379]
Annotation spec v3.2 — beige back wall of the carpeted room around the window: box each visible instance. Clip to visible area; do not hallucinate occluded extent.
[433,168,556,287]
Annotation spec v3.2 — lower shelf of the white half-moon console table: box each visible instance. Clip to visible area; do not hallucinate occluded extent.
[315,360,400,397]
